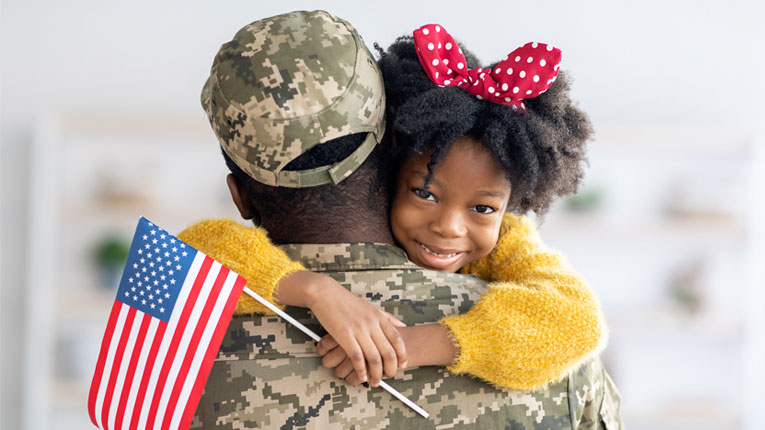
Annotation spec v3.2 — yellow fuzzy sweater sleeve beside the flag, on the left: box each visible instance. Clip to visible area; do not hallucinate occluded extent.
[178,220,304,315]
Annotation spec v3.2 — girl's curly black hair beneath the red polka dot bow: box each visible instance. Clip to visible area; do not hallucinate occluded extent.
[375,36,592,216]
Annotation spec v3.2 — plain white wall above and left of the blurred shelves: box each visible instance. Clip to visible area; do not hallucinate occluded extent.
[0,0,765,429]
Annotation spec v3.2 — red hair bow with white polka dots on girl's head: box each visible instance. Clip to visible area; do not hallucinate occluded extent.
[414,24,561,112]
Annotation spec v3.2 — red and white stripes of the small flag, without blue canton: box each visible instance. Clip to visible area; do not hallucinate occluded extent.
[88,235,245,430]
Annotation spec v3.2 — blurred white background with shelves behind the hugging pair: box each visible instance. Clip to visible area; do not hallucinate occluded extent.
[0,0,765,429]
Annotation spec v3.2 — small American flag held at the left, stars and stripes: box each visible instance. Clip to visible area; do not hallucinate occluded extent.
[88,217,245,430]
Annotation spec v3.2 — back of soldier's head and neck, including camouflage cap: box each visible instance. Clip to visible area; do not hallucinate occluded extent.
[202,11,390,242]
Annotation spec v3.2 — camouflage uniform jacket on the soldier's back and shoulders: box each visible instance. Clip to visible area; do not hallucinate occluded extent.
[191,244,622,430]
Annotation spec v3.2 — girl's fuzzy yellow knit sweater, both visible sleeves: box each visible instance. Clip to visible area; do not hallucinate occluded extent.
[178,214,607,389]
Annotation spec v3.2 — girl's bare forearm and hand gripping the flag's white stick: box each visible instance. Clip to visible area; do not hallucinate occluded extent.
[276,271,406,386]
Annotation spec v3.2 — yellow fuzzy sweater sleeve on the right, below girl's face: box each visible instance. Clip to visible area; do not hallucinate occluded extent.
[441,214,607,389]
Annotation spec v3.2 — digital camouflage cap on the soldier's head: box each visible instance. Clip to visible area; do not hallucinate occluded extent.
[202,11,385,188]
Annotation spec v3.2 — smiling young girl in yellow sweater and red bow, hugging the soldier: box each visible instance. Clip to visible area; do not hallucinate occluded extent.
[181,25,607,389]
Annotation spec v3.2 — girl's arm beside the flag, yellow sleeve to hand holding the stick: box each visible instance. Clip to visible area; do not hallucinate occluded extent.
[178,220,407,385]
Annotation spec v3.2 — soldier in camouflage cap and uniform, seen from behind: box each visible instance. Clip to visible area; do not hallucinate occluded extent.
[180,11,620,429]
